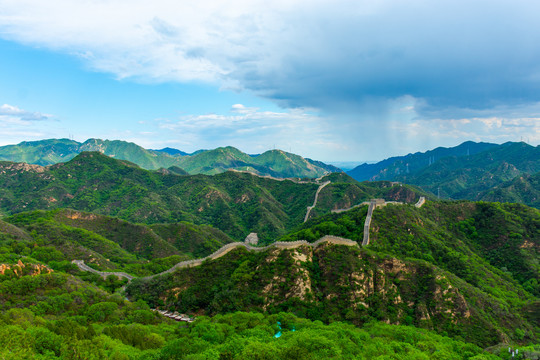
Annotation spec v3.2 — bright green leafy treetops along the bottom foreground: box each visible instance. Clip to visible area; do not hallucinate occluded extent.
[0,266,504,360]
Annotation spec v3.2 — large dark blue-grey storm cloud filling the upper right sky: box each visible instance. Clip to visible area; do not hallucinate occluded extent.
[232,1,540,112]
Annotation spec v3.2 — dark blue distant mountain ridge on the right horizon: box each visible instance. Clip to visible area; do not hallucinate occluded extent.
[348,141,540,207]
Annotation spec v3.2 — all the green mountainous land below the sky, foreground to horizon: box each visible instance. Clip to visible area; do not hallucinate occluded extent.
[0,139,540,359]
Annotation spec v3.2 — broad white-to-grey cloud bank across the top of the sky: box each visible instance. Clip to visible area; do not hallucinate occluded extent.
[0,0,540,116]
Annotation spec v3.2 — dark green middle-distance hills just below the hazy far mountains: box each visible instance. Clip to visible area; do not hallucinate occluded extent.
[0,153,424,241]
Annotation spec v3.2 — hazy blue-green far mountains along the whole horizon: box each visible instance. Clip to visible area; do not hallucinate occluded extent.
[0,139,540,207]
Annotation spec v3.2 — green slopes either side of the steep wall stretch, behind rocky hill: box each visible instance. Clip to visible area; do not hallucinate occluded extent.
[279,201,540,296]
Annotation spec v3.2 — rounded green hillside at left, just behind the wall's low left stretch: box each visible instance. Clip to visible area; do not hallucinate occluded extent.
[0,210,233,276]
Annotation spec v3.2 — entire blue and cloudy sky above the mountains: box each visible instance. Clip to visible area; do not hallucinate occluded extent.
[0,0,540,162]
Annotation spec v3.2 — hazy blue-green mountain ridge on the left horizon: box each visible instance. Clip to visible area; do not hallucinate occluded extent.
[0,139,341,178]
